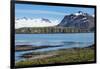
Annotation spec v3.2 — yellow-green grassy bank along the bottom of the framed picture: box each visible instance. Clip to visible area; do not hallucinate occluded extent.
[15,46,95,67]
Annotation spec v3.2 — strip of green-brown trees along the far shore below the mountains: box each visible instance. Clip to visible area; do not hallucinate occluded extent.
[15,27,90,34]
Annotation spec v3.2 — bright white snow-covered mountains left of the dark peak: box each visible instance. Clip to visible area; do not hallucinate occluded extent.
[15,17,59,29]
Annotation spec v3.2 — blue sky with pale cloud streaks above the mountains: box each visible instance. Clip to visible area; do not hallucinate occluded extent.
[15,4,94,21]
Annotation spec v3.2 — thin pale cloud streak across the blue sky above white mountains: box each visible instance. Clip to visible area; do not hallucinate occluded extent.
[15,9,67,15]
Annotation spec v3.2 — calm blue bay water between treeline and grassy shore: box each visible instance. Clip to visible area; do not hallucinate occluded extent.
[15,33,94,60]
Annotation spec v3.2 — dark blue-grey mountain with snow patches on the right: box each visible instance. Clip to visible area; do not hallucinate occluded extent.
[58,11,94,30]
